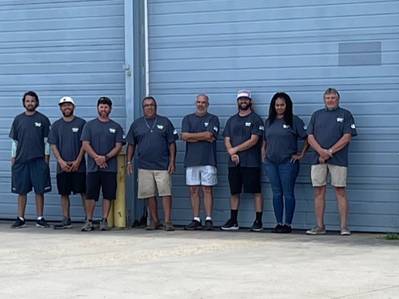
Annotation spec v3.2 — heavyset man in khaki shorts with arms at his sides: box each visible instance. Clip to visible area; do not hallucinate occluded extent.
[126,96,178,231]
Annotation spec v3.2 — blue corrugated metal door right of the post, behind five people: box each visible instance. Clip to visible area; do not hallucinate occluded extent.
[149,0,399,231]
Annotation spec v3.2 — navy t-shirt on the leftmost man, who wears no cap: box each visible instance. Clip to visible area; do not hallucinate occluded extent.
[9,111,50,163]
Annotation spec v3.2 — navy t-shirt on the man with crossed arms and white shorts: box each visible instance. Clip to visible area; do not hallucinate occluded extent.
[182,113,220,167]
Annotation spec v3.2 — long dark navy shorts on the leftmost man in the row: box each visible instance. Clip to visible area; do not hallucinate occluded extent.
[11,158,51,194]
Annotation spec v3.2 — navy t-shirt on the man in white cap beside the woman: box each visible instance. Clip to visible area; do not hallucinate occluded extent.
[223,112,264,167]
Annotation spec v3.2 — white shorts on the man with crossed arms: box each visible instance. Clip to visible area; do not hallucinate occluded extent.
[186,165,218,186]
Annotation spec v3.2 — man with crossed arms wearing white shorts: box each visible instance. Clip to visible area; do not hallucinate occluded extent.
[182,94,219,230]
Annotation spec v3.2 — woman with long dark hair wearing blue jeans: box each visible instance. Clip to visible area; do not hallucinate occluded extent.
[262,92,309,233]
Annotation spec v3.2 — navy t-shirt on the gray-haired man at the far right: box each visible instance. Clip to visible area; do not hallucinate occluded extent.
[308,107,357,166]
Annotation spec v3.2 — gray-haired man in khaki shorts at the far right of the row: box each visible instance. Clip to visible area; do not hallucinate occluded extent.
[306,88,357,236]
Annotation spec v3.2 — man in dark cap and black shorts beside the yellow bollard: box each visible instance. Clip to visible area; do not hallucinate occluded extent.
[81,97,123,231]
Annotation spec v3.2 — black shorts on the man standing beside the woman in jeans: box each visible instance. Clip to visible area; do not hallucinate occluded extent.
[229,166,261,195]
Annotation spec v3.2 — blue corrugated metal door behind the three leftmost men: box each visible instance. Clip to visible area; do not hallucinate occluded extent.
[0,0,125,219]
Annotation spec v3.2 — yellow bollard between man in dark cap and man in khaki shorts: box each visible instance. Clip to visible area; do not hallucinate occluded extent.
[113,153,126,228]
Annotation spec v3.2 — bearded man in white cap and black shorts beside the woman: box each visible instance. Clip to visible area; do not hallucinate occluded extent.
[221,90,264,232]
